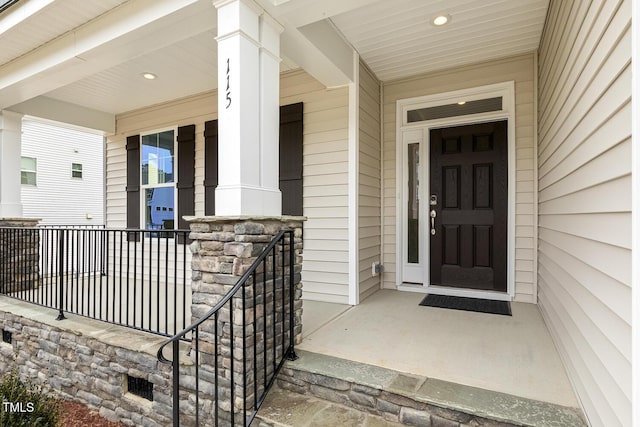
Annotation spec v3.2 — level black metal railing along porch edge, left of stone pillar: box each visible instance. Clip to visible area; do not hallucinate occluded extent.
[0,226,191,336]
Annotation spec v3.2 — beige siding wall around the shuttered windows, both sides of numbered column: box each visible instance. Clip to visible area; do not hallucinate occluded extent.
[106,71,349,303]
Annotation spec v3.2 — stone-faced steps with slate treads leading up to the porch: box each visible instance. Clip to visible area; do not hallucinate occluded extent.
[260,351,586,427]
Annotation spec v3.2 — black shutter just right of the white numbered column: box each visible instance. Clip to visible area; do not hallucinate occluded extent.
[280,102,303,215]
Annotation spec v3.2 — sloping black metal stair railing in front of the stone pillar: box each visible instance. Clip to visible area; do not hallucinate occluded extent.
[158,230,297,427]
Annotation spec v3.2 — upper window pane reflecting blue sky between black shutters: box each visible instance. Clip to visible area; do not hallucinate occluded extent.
[142,130,175,185]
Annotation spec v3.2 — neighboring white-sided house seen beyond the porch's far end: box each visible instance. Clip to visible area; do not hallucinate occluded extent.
[20,117,104,225]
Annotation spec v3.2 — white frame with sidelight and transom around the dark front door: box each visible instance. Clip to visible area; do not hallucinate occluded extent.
[396,81,516,301]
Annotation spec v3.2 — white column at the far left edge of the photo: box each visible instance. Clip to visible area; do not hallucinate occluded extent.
[0,110,22,218]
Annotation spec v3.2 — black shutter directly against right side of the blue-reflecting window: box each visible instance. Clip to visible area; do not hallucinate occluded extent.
[176,125,196,243]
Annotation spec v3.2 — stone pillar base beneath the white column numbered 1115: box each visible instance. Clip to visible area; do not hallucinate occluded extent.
[188,217,303,425]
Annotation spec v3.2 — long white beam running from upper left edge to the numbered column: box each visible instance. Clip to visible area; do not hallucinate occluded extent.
[0,0,216,109]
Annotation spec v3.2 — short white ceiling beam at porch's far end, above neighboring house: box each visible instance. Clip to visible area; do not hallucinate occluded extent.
[8,96,116,135]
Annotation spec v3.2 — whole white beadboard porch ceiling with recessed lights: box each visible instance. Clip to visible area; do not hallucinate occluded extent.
[0,0,548,122]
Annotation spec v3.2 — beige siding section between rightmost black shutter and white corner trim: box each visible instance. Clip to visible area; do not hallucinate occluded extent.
[280,71,349,304]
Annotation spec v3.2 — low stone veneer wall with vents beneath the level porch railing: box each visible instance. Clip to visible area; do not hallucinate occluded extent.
[0,310,175,427]
